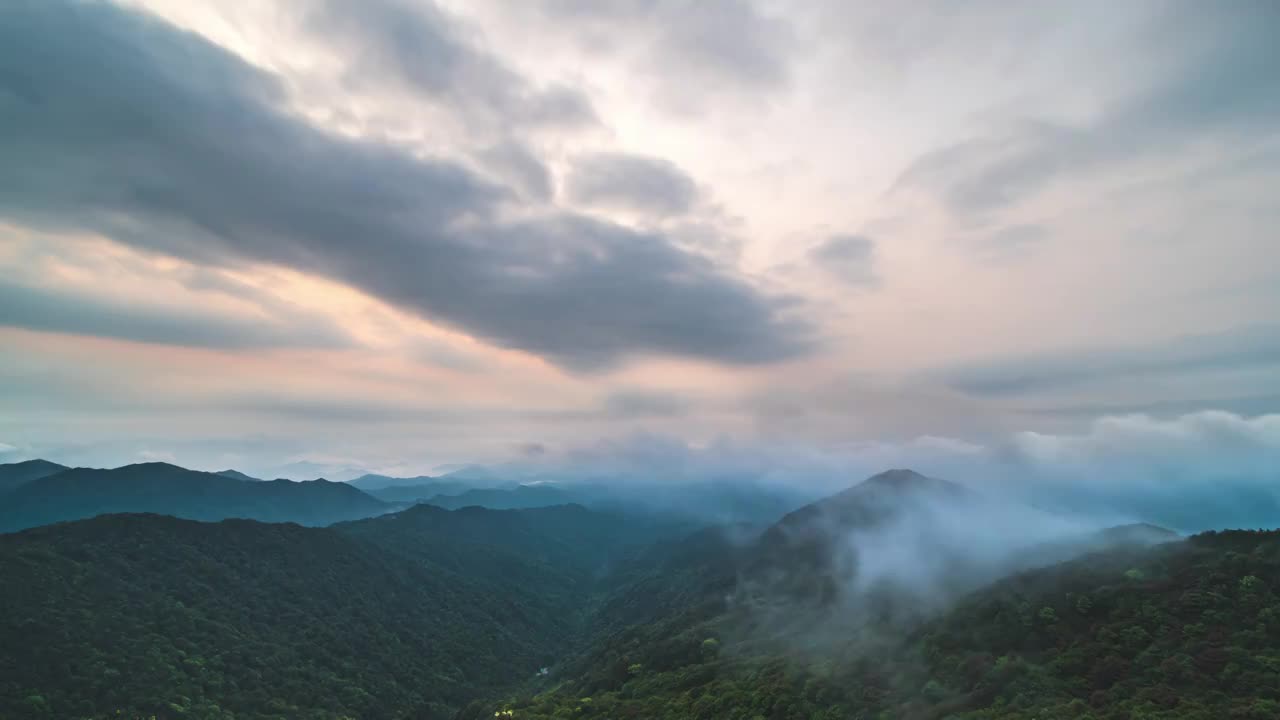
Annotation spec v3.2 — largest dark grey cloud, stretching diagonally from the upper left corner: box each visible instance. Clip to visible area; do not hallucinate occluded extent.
[0,1,810,369]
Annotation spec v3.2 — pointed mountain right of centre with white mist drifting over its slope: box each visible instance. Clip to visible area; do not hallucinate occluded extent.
[478,470,1187,717]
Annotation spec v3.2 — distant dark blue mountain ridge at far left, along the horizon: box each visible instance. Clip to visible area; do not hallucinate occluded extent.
[0,462,390,530]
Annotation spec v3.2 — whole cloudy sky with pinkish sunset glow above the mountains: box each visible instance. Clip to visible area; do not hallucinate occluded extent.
[0,0,1280,478]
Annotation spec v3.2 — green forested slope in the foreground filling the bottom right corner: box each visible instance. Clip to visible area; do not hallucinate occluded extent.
[481,528,1280,720]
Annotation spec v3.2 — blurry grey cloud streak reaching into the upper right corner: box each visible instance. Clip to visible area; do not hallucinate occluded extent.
[897,0,1280,213]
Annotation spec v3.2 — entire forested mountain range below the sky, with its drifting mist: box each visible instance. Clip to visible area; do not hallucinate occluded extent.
[0,464,1280,720]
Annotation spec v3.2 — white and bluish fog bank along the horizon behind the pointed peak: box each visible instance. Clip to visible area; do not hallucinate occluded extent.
[504,411,1280,537]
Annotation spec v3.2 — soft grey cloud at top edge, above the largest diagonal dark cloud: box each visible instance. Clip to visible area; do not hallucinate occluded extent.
[305,0,596,127]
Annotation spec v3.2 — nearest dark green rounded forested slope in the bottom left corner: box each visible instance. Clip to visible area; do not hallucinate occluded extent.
[0,515,576,720]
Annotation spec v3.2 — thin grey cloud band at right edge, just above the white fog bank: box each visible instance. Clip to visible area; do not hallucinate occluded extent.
[940,325,1280,396]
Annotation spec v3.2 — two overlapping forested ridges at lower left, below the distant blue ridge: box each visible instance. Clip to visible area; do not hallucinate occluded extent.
[0,502,684,720]
